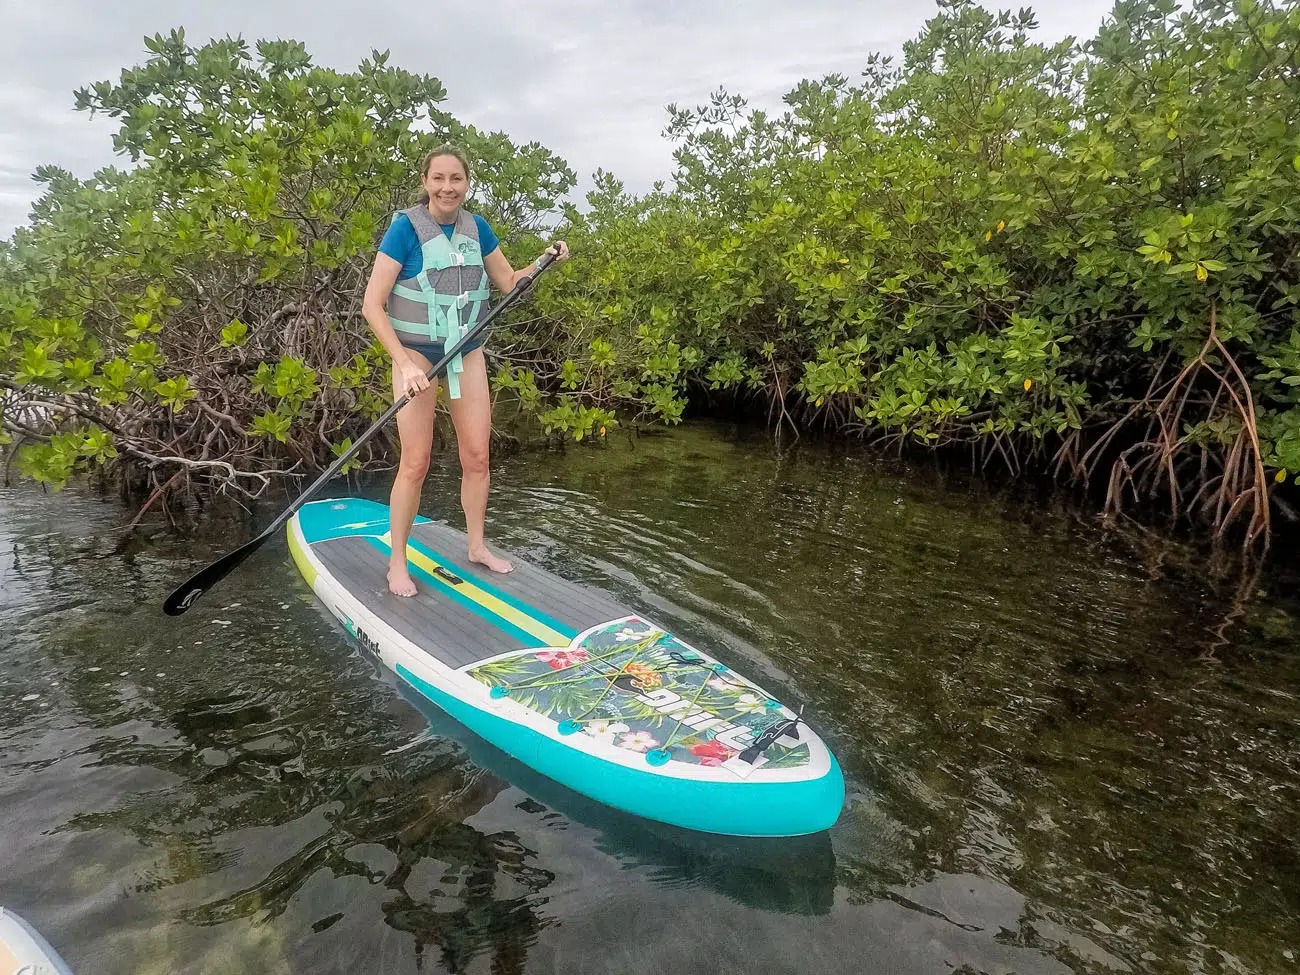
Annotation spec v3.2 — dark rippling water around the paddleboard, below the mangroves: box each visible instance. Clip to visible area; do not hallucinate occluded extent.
[0,425,1300,975]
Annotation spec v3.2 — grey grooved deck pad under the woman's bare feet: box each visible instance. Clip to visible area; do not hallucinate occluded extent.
[312,523,634,667]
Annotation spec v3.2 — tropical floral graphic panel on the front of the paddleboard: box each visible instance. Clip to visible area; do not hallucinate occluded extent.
[468,616,809,768]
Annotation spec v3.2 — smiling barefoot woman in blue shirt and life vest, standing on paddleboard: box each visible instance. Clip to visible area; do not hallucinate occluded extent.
[361,146,568,595]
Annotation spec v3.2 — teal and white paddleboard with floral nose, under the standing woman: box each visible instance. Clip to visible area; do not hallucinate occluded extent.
[287,498,844,836]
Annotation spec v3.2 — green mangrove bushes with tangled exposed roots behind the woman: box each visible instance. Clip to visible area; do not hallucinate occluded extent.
[0,0,1300,553]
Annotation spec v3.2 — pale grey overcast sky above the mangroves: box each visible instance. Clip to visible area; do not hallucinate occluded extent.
[0,0,1112,238]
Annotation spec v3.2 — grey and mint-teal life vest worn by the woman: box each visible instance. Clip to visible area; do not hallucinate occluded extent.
[387,205,491,399]
